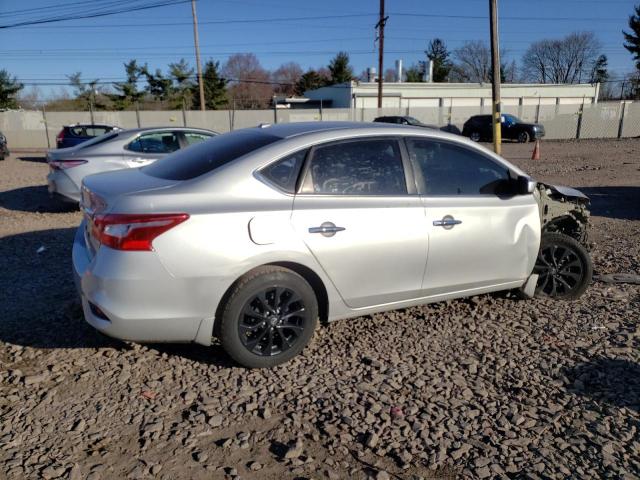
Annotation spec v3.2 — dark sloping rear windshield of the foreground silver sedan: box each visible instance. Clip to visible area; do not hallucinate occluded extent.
[142,129,282,180]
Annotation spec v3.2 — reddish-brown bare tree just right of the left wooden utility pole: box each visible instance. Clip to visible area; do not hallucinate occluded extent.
[222,53,274,108]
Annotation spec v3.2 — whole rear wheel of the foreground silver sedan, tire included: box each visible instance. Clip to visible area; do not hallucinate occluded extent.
[220,266,318,368]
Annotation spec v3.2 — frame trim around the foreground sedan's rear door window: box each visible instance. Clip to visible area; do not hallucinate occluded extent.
[296,135,417,198]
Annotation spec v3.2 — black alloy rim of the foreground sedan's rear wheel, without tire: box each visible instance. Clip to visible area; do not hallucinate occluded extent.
[238,287,310,356]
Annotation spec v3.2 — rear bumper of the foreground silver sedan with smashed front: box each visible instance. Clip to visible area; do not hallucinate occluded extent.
[72,221,206,342]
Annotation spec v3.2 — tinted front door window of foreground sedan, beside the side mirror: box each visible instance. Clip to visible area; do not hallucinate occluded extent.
[407,139,509,196]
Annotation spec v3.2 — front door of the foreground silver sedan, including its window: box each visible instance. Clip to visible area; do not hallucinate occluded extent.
[407,138,540,296]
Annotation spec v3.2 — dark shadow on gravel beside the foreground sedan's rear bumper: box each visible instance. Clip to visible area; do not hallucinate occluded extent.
[0,228,129,349]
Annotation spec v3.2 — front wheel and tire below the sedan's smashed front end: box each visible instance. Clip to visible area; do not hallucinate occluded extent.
[533,233,593,300]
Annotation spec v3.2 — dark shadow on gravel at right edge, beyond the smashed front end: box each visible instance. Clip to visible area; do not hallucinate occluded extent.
[579,187,640,220]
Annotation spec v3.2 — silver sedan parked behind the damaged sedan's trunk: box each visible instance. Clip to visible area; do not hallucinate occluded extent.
[47,127,217,202]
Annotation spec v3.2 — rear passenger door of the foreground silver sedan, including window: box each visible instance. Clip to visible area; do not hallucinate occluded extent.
[291,137,428,308]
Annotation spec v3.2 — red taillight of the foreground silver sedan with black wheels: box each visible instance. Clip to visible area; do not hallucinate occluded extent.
[92,213,189,251]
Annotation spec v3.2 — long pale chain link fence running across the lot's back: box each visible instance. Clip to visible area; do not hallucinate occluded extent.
[0,101,640,149]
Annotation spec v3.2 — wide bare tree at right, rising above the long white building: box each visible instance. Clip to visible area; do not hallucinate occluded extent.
[522,32,600,83]
